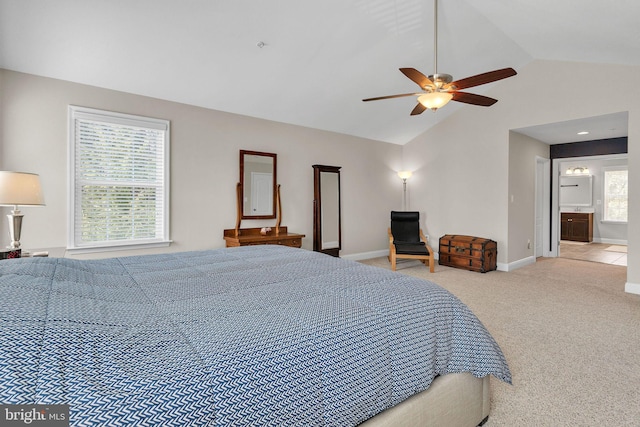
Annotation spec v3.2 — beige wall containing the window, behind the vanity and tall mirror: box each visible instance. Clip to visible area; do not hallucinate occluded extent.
[0,70,402,257]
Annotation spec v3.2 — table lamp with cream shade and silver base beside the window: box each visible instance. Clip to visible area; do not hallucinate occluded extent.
[0,171,44,250]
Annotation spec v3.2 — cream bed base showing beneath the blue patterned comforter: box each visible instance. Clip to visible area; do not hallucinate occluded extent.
[360,373,490,427]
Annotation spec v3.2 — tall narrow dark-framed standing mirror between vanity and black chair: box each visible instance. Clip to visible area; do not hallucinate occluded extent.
[313,165,342,257]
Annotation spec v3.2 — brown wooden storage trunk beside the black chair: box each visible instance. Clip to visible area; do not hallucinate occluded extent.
[438,234,498,273]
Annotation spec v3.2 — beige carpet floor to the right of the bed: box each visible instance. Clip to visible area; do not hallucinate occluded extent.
[363,257,640,427]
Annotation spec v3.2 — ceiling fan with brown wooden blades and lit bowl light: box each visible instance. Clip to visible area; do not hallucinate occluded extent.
[363,0,517,116]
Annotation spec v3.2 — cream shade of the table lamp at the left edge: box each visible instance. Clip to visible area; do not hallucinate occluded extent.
[0,171,44,206]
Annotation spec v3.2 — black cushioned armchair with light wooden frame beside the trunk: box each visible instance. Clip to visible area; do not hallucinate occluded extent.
[389,211,435,273]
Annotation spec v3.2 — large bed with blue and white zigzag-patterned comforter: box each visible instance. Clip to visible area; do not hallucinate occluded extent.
[0,245,511,427]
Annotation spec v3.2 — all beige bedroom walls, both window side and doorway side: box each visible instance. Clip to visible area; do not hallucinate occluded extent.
[0,61,640,292]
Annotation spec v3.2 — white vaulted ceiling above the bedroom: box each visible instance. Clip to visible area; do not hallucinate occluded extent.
[0,0,640,144]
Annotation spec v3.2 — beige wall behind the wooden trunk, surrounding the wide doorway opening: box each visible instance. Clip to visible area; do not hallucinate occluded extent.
[403,61,640,286]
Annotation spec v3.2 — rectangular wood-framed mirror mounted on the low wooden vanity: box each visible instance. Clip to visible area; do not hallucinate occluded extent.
[240,150,277,219]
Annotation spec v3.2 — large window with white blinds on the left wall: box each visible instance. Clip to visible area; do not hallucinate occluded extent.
[68,106,169,250]
